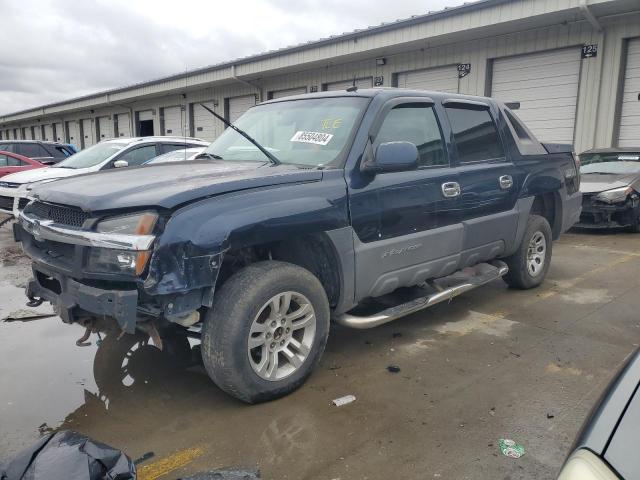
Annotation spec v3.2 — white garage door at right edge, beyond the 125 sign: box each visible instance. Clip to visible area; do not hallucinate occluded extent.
[618,38,640,147]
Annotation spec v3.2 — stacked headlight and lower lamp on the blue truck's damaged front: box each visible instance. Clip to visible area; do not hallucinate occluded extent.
[87,212,158,276]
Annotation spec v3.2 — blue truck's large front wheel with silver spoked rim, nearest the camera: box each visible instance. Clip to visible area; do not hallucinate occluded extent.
[202,261,329,403]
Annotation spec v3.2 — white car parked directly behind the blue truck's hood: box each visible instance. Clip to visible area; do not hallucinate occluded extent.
[0,137,209,218]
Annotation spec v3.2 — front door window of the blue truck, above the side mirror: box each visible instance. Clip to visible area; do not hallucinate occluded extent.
[376,103,449,167]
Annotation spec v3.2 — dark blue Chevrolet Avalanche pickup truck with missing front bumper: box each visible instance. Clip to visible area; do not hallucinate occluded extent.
[15,88,581,402]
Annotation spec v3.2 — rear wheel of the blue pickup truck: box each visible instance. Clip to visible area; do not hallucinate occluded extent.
[503,215,553,290]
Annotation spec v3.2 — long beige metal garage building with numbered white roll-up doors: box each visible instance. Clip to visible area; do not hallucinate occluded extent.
[0,0,640,152]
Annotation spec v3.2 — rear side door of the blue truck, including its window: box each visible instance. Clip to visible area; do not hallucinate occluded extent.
[443,100,520,267]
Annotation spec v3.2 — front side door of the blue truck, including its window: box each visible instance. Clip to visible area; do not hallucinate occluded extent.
[348,97,462,300]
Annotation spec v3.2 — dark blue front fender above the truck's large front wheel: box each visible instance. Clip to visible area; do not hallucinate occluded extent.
[144,170,349,295]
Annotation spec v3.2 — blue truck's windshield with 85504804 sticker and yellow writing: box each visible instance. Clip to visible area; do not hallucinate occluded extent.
[205,97,368,167]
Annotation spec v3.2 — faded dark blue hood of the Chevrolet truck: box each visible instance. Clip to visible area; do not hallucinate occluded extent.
[33,160,322,211]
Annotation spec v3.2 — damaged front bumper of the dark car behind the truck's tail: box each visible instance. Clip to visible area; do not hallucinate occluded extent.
[575,194,640,229]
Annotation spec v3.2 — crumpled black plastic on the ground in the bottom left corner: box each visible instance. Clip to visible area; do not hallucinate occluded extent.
[0,430,136,480]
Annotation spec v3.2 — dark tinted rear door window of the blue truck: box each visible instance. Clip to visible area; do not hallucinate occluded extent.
[446,105,504,163]
